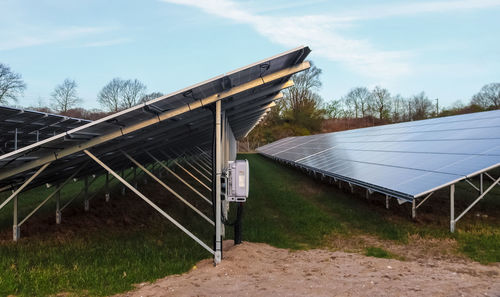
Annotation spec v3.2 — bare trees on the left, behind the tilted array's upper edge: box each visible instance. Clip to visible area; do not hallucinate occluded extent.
[0,63,163,120]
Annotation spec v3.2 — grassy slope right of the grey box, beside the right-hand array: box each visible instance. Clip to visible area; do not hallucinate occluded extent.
[234,154,500,263]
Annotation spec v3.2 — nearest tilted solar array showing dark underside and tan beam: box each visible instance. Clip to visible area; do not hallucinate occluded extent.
[0,47,310,189]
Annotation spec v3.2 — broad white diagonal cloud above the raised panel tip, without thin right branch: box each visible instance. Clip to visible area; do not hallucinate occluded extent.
[163,0,411,79]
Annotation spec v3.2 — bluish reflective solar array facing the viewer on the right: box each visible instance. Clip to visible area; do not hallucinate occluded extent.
[257,110,500,201]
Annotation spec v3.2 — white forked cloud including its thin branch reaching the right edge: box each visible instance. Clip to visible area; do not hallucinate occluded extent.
[162,0,500,82]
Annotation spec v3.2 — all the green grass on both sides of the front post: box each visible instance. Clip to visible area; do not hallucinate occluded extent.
[0,154,500,296]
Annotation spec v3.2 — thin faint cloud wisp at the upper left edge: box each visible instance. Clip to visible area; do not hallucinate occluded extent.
[0,25,115,51]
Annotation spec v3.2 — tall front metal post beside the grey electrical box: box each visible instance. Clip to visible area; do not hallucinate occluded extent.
[214,100,222,265]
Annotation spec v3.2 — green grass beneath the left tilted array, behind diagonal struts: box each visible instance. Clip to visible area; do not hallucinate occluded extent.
[0,163,213,296]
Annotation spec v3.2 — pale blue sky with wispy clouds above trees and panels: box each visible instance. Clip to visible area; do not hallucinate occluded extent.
[0,0,500,108]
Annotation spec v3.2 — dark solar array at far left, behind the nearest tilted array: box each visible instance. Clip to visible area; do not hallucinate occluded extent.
[0,106,90,154]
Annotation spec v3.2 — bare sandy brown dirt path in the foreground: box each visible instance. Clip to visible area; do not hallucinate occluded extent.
[117,242,500,297]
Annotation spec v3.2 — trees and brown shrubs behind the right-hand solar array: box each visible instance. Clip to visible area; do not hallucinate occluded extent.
[244,64,500,150]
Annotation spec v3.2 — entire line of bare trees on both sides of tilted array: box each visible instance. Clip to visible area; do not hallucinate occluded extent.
[0,63,500,143]
